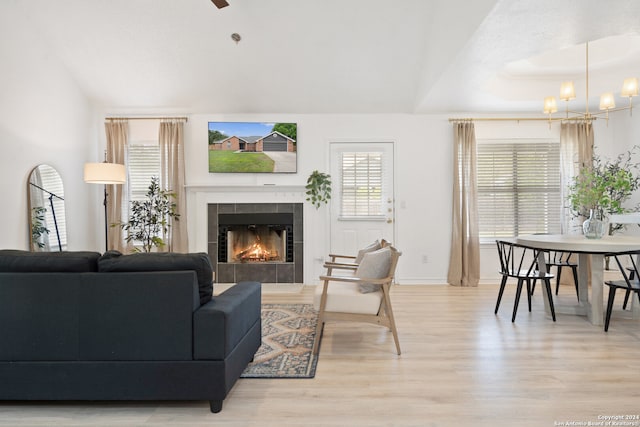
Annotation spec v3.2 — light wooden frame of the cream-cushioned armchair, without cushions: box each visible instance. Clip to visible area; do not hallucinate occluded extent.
[313,246,401,354]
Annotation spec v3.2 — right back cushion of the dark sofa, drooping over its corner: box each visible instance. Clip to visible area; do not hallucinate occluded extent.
[98,251,213,305]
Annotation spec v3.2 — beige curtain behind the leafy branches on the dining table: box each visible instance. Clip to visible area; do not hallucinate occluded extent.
[560,121,593,234]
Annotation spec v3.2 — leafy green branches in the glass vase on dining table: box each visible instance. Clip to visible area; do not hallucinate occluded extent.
[569,145,640,234]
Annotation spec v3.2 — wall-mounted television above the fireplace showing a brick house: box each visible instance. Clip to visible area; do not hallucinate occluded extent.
[208,122,298,173]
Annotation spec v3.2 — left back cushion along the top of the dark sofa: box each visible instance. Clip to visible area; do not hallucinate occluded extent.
[0,249,100,273]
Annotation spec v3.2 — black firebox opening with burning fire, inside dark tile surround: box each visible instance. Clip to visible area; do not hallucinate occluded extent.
[218,213,293,263]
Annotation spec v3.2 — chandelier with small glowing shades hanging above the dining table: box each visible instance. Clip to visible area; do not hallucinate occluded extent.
[543,42,638,123]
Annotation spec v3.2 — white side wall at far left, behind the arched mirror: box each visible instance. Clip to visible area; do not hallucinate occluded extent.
[0,2,99,250]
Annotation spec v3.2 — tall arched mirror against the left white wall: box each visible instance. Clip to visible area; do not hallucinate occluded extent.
[27,165,67,252]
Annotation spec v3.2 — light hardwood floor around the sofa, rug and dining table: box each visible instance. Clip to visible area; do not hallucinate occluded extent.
[0,285,640,427]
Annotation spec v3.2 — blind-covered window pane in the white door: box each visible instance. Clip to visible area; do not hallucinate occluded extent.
[340,152,384,219]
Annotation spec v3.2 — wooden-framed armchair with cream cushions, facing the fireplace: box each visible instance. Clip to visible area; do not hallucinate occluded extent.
[313,245,401,354]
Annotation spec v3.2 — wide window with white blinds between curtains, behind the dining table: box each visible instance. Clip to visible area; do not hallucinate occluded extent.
[477,139,562,242]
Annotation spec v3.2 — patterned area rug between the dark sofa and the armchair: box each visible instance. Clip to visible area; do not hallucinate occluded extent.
[241,304,318,378]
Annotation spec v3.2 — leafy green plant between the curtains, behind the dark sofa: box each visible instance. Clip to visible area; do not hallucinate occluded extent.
[114,176,180,252]
